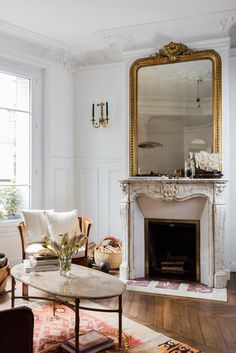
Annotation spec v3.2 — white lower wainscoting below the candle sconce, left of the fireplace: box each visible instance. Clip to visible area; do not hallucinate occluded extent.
[75,159,124,243]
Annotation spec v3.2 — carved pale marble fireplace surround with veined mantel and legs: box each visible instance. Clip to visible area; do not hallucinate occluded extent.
[120,177,227,288]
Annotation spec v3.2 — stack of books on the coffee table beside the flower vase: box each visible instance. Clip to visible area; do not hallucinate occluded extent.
[24,255,59,272]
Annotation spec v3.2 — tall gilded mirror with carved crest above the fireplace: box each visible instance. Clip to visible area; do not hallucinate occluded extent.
[130,42,221,176]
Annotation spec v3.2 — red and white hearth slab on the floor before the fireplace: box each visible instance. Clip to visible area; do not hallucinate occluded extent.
[124,279,227,301]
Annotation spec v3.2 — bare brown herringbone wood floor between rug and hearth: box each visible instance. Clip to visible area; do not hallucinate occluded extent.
[97,273,236,353]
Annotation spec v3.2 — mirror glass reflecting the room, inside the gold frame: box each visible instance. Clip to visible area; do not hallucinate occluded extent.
[137,60,213,175]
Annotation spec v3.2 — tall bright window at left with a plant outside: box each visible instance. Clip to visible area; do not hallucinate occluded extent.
[0,66,40,216]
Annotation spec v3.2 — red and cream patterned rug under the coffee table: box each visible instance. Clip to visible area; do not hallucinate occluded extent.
[33,303,201,353]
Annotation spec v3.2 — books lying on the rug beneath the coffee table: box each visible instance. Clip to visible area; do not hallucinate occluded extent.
[61,330,114,353]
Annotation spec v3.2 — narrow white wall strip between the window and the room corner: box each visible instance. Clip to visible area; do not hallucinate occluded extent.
[41,64,74,211]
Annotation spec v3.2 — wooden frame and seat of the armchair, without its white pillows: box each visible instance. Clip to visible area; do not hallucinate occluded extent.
[17,217,92,296]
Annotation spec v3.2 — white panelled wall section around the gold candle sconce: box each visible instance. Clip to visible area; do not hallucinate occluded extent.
[74,64,128,242]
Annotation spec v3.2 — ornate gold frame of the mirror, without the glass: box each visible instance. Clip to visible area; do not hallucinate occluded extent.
[129,42,222,176]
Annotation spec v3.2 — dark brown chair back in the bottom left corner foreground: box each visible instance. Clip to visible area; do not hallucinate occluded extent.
[0,306,34,353]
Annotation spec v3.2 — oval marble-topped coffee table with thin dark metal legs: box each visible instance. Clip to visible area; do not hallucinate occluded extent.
[11,264,126,353]
